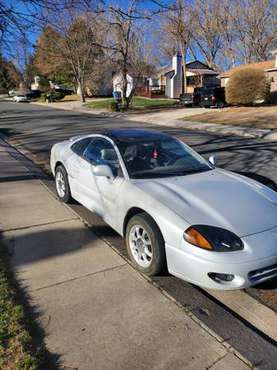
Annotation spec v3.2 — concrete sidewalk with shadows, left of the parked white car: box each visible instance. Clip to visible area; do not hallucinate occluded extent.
[0,141,248,370]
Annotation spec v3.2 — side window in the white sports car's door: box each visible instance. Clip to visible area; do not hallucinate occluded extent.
[84,138,122,176]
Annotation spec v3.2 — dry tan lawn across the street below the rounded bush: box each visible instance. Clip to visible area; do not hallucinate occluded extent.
[184,105,277,130]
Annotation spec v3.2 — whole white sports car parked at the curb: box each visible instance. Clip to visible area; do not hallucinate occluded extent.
[51,129,277,289]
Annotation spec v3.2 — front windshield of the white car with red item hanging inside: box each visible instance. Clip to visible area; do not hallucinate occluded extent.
[117,138,212,179]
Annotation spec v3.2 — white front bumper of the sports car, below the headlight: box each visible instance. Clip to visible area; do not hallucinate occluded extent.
[166,244,277,290]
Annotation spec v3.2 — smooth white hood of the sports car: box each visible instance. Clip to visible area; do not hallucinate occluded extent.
[136,169,277,237]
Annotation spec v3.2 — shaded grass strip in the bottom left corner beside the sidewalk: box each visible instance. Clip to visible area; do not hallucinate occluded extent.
[0,242,47,370]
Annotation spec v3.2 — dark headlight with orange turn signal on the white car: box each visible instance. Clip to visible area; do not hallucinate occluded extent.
[184,225,243,252]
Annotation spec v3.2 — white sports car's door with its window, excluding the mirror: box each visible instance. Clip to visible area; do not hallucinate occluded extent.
[84,137,125,229]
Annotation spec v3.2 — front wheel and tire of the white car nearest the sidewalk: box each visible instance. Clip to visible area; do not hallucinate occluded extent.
[126,213,166,276]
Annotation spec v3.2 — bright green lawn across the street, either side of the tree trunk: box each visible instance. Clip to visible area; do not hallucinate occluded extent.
[85,96,176,109]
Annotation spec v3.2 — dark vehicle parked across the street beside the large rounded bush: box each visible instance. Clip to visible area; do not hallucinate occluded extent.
[199,87,226,108]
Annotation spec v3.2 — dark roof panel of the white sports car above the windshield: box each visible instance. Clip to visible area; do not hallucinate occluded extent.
[103,128,172,142]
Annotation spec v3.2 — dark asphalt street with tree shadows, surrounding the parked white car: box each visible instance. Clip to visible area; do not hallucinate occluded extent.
[0,102,277,369]
